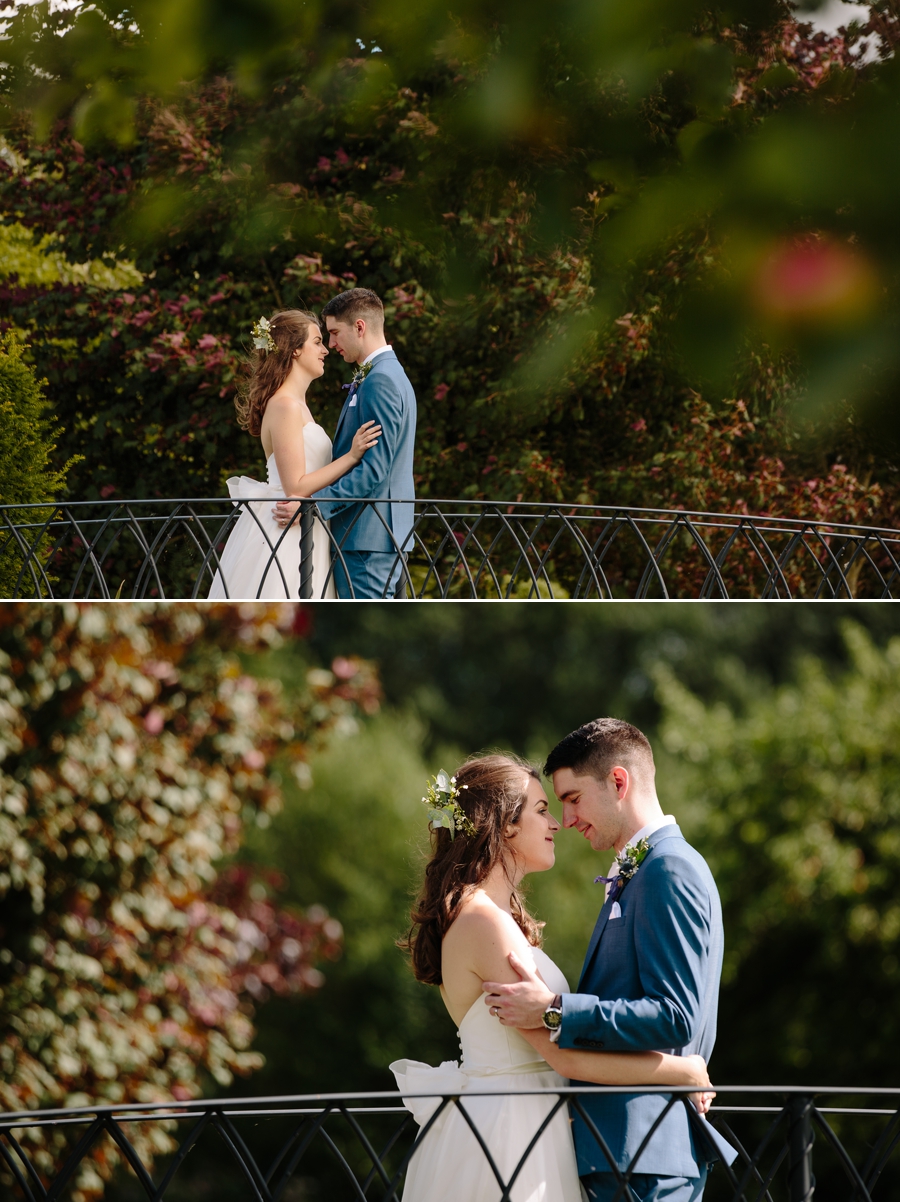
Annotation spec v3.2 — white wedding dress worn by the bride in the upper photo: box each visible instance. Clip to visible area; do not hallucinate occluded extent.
[208,422,334,601]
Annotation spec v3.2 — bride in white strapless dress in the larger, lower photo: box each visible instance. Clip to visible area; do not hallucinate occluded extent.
[391,755,711,1202]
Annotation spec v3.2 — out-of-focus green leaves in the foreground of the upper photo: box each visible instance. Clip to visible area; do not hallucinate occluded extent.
[5,0,900,492]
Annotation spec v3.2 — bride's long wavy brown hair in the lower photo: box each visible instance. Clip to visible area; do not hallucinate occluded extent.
[399,754,543,984]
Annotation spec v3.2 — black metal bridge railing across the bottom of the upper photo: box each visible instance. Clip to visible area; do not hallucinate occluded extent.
[0,499,900,600]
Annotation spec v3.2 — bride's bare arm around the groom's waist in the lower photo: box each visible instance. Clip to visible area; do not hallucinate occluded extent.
[511,1028,709,1089]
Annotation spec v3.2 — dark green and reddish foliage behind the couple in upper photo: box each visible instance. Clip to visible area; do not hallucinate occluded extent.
[0,7,896,523]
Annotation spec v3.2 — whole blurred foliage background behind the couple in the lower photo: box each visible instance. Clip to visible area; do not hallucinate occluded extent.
[0,602,900,1200]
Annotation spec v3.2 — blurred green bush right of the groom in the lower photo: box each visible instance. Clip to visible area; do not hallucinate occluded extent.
[658,621,900,1085]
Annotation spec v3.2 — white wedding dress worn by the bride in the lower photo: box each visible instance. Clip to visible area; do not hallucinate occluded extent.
[391,947,583,1202]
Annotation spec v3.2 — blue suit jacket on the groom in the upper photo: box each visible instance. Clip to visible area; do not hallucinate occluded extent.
[312,351,416,552]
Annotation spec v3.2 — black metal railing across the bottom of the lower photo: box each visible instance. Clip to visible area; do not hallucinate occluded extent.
[0,1085,900,1202]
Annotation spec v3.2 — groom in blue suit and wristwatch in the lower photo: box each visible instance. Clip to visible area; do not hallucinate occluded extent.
[484,718,737,1202]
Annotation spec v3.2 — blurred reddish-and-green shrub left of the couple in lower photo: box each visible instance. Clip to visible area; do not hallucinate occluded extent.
[0,603,375,1202]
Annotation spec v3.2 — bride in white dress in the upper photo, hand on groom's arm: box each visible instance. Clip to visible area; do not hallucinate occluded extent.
[209,309,381,601]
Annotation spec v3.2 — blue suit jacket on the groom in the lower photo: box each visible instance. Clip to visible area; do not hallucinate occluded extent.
[559,823,737,1177]
